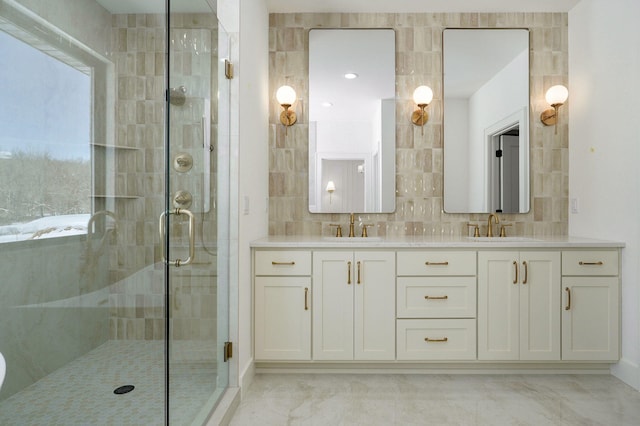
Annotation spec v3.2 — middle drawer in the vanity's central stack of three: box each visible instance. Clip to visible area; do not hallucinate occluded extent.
[396,277,476,318]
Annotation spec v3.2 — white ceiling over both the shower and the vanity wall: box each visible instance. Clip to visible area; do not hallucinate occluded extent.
[96,0,580,13]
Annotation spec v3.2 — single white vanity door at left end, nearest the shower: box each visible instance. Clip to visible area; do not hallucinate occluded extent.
[255,277,311,361]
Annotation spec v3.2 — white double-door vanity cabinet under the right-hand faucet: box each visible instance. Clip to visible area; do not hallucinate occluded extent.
[478,251,561,361]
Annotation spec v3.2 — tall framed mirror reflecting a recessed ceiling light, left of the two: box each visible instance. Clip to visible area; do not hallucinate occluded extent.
[309,29,396,213]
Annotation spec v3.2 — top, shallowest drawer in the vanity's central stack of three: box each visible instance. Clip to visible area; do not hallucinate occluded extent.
[398,251,476,276]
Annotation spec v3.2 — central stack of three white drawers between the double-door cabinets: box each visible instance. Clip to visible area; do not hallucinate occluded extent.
[396,251,476,361]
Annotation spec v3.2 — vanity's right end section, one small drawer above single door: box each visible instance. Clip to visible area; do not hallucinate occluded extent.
[562,250,620,361]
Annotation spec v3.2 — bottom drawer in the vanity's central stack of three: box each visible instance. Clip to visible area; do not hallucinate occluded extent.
[396,319,476,361]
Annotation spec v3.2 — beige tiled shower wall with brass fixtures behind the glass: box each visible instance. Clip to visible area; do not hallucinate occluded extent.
[106,14,217,340]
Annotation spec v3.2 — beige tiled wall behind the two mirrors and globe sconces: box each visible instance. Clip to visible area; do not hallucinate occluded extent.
[269,13,570,237]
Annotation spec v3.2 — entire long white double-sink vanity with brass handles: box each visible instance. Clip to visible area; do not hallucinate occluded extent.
[252,237,624,371]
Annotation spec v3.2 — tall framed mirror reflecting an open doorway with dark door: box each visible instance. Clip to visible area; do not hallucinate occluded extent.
[442,29,530,213]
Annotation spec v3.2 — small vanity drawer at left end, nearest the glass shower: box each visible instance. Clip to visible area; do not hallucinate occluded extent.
[255,250,311,276]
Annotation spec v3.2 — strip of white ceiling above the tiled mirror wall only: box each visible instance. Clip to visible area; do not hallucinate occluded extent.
[266,0,580,13]
